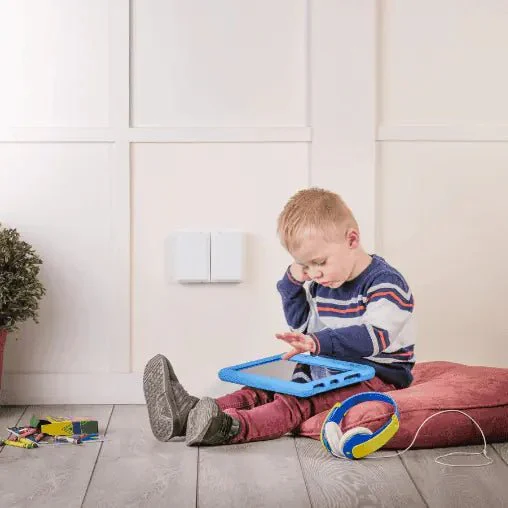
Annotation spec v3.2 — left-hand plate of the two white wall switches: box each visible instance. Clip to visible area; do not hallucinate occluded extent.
[174,231,210,283]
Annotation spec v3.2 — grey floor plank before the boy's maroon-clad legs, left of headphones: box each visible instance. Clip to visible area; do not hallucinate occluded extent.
[197,437,310,508]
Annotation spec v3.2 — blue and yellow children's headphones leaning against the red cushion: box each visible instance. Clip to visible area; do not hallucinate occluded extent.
[321,392,400,459]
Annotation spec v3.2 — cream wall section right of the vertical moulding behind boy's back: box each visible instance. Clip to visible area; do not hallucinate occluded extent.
[377,0,508,367]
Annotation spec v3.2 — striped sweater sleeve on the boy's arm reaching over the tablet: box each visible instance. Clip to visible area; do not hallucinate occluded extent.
[310,273,414,359]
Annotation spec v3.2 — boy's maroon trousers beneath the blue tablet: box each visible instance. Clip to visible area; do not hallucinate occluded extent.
[217,377,395,443]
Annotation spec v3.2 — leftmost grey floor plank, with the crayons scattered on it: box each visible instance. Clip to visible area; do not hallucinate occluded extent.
[0,405,112,508]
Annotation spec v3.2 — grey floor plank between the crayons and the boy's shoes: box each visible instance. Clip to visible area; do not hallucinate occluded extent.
[84,405,198,508]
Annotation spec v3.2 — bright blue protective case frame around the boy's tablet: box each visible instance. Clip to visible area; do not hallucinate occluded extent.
[219,354,375,397]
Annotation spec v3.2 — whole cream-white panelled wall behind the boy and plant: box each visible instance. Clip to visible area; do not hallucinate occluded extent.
[0,0,508,403]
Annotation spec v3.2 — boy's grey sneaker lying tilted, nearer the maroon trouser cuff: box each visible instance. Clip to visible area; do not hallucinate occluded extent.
[185,397,240,446]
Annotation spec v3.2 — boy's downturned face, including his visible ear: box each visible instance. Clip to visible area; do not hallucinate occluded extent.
[291,230,359,288]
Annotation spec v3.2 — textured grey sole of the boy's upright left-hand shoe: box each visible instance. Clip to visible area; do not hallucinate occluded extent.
[143,355,176,441]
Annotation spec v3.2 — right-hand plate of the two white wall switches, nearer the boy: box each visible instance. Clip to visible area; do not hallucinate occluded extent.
[210,231,245,282]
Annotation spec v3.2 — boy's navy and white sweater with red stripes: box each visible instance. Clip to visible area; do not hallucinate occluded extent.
[277,255,415,388]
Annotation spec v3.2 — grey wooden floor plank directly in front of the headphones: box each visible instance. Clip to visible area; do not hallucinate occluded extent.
[297,438,425,508]
